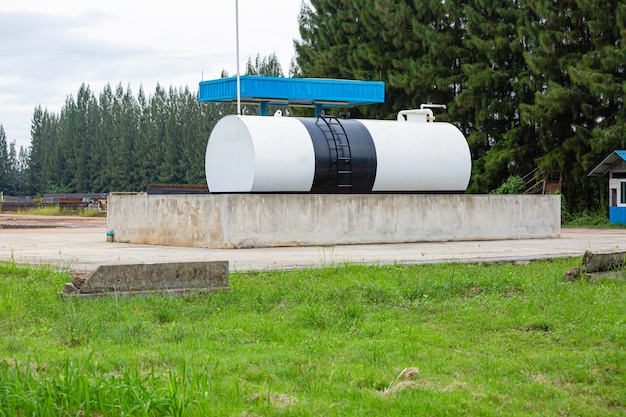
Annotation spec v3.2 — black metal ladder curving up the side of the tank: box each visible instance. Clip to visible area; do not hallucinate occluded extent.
[316,116,352,193]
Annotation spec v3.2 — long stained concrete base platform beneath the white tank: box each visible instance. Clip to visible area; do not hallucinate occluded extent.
[107,194,561,249]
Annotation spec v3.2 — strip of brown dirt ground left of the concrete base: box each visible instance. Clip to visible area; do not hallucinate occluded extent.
[0,213,107,229]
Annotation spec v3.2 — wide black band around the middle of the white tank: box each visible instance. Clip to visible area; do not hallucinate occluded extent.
[298,118,377,193]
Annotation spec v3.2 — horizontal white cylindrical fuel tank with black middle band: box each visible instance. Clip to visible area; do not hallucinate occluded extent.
[206,109,471,193]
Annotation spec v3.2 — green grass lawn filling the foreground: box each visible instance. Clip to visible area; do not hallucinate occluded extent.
[0,259,626,417]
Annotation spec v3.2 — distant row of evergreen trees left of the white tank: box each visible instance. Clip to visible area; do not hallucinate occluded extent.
[0,54,283,195]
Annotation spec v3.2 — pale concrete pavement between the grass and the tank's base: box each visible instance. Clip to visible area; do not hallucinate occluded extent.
[0,214,626,272]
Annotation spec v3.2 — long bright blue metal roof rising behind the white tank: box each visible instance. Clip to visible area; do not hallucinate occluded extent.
[198,75,385,107]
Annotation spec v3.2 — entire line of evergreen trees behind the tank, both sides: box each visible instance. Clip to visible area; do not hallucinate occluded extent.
[0,0,626,210]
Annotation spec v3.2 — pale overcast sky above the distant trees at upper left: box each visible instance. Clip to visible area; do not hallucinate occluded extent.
[0,0,302,150]
